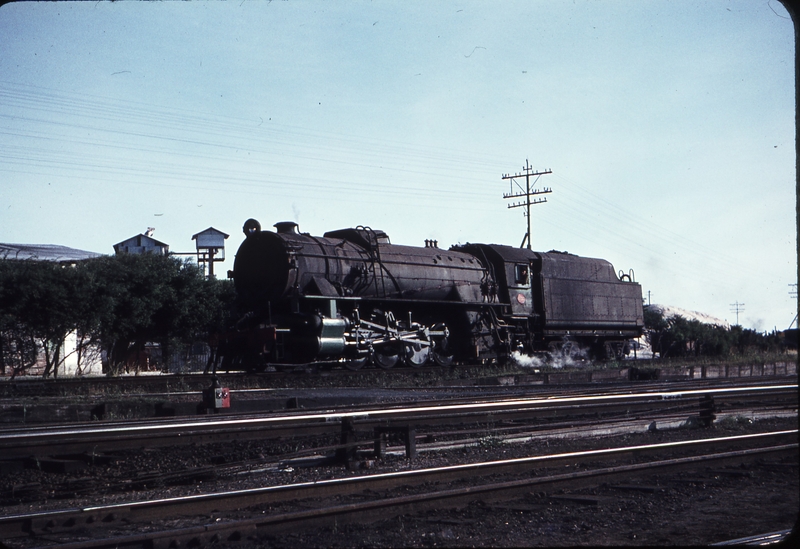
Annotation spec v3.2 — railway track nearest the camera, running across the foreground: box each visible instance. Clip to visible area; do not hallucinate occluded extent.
[0,430,798,547]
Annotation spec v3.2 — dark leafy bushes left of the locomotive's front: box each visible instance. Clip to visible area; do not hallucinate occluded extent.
[0,254,233,377]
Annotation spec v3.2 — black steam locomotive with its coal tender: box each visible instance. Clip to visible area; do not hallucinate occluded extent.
[219,219,644,370]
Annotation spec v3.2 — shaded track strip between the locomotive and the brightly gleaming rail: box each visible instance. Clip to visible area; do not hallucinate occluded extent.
[0,366,796,426]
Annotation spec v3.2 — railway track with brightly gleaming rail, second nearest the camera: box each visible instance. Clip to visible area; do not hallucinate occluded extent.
[0,384,797,460]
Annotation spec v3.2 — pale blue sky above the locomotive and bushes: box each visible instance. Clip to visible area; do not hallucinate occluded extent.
[0,0,797,331]
